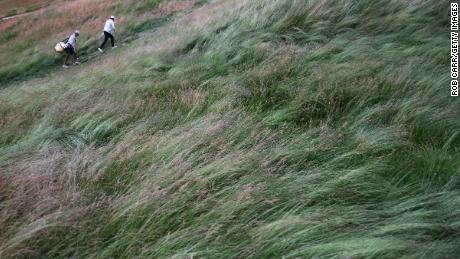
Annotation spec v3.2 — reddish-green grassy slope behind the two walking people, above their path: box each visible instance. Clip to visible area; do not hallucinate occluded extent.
[0,0,172,87]
